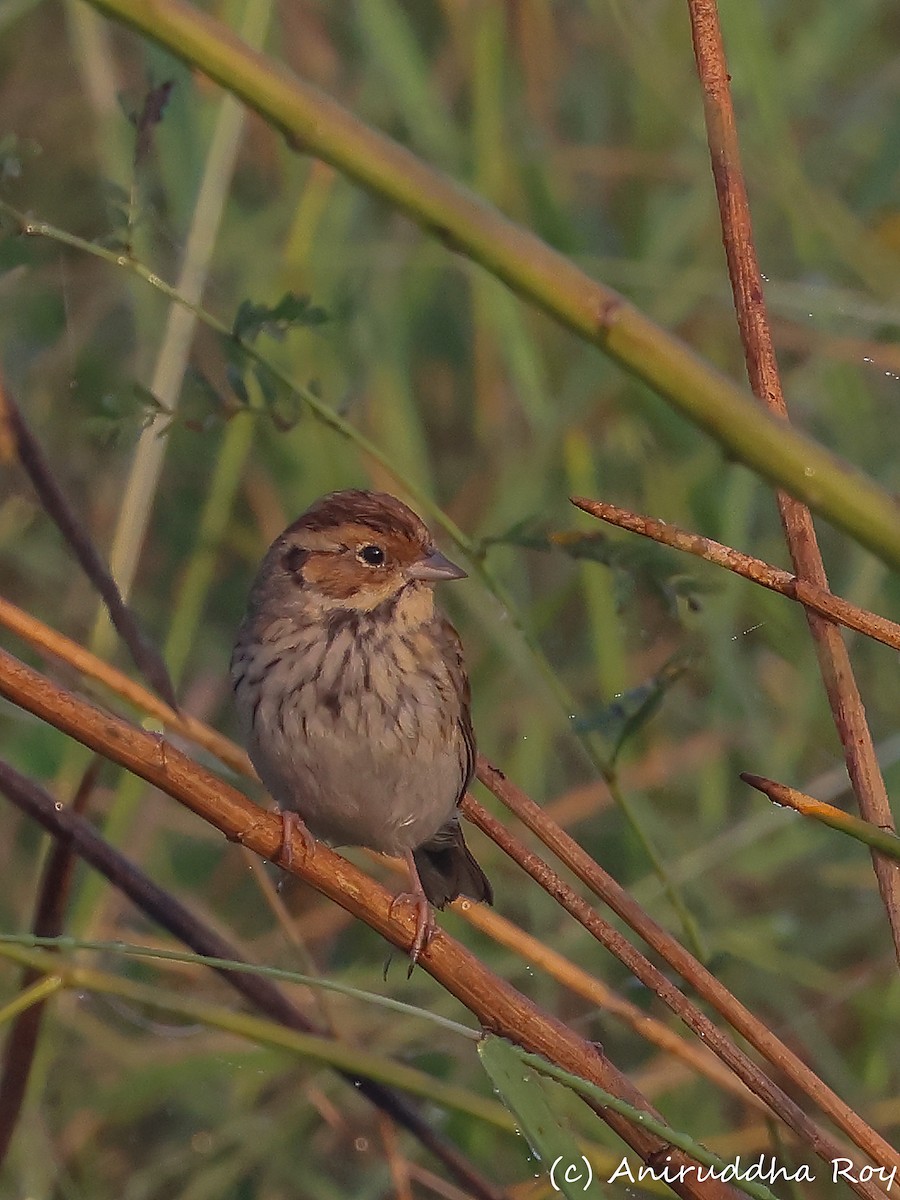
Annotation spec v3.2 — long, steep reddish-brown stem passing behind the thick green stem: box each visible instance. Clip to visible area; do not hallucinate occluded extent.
[688,0,900,962]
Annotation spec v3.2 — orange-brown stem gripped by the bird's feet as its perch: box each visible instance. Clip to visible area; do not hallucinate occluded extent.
[0,650,753,1200]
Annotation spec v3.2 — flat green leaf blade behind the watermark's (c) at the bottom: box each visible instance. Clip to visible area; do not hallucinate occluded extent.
[478,1034,602,1200]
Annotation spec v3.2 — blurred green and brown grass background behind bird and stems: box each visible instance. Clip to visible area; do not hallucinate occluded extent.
[0,0,900,1200]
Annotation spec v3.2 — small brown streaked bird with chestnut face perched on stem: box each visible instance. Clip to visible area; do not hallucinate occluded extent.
[232,491,493,964]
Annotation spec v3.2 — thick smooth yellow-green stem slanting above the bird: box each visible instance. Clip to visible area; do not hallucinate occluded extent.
[72,0,900,565]
